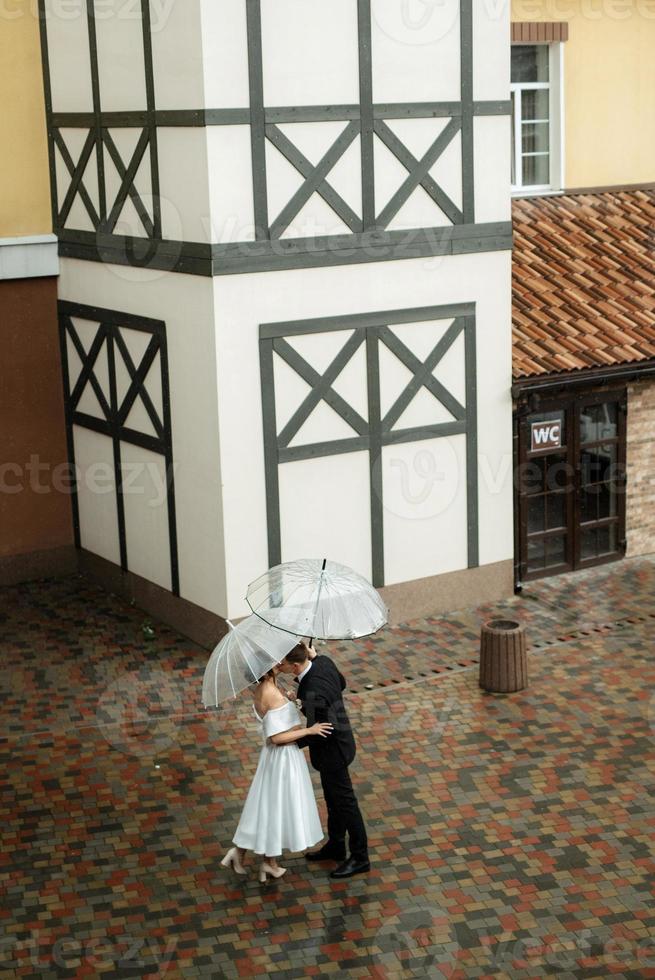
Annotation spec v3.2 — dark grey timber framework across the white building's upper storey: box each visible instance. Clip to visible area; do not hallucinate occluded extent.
[38,0,511,275]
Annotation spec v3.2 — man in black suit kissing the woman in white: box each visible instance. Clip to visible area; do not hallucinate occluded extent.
[285,643,371,878]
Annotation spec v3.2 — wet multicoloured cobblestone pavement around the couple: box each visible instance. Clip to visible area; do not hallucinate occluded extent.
[0,560,655,980]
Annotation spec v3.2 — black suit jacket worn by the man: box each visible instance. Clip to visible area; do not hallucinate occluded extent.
[296,654,356,772]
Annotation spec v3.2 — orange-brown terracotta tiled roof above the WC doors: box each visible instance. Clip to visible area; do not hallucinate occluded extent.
[512,189,655,378]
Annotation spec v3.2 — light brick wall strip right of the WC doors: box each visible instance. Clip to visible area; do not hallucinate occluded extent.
[626,381,655,555]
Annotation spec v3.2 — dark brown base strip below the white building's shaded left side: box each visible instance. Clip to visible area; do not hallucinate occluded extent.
[78,548,228,650]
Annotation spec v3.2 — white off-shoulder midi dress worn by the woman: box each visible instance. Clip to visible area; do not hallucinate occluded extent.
[233,701,324,857]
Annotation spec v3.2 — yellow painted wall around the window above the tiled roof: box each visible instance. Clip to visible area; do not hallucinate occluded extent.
[512,0,655,188]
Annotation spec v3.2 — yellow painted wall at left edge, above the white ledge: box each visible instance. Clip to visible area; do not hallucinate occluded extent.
[0,0,52,238]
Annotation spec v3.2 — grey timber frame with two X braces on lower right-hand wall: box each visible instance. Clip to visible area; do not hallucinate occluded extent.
[259,303,478,587]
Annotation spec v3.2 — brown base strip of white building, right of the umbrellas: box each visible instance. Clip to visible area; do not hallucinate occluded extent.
[380,559,514,626]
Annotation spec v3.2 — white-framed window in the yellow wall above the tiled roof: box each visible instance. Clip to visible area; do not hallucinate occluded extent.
[510,43,563,193]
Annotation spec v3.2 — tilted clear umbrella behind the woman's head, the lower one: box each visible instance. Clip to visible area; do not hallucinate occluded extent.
[202,616,298,708]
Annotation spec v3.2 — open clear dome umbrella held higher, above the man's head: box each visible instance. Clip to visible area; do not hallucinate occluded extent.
[246,558,388,640]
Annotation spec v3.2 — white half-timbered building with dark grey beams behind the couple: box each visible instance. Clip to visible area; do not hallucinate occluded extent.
[40,0,512,633]
